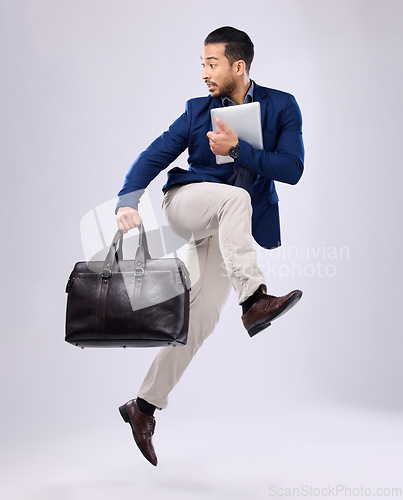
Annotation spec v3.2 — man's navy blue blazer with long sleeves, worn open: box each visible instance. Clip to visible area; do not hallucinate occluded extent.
[116,83,304,248]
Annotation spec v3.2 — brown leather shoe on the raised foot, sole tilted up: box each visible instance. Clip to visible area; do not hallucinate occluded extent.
[242,290,302,337]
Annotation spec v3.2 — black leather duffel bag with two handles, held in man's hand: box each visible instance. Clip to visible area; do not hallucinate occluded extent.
[65,224,190,348]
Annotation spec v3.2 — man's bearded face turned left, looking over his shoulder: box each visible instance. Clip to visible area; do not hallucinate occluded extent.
[201,43,236,97]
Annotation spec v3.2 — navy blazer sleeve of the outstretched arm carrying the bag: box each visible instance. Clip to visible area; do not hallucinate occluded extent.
[115,101,191,213]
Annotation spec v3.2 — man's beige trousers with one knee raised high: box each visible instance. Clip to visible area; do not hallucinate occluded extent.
[138,182,266,409]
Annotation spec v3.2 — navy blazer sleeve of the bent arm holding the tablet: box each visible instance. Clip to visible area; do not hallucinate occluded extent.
[236,94,305,184]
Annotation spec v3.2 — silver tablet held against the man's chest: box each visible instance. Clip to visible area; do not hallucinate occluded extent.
[211,102,263,165]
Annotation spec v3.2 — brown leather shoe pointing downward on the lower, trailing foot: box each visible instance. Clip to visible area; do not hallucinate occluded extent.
[119,399,158,465]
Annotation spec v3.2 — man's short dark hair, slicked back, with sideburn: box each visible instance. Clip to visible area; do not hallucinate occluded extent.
[204,26,254,73]
